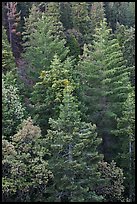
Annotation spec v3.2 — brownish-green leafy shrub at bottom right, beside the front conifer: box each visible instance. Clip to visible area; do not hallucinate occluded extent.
[97,161,124,202]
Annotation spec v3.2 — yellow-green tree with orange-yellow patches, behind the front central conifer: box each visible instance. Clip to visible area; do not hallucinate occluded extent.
[32,55,74,133]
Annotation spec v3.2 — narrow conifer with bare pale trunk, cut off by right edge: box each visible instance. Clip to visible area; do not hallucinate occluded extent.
[114,92,135,201]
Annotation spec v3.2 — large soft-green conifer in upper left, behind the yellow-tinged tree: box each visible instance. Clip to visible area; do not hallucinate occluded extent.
[23,3,68,82]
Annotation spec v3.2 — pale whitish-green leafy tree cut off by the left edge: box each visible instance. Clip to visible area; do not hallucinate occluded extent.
[2,72,25,140]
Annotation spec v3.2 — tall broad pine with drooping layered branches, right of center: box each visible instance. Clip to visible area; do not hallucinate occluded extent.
[77,20,131,160]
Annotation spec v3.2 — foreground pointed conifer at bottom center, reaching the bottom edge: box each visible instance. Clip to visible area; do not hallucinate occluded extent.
[45,85,102,202]
